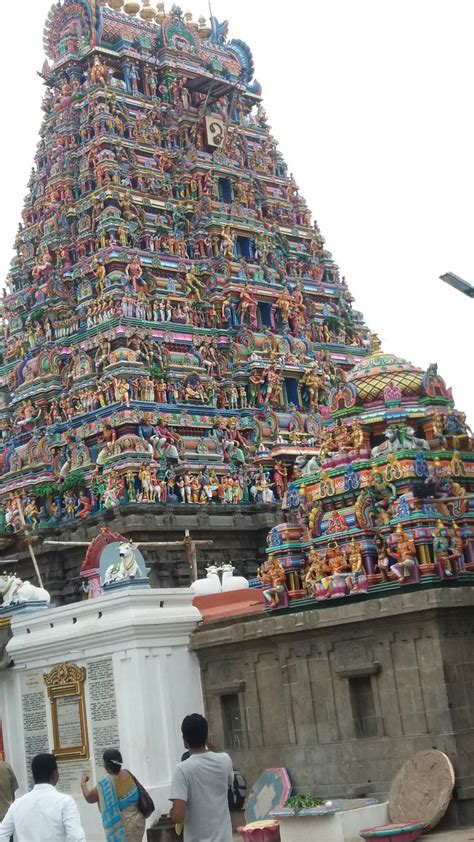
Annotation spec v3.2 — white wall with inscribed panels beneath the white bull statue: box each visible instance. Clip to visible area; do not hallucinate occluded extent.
[0,588,203,842]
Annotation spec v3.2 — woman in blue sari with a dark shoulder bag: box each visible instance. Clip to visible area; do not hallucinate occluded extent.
[81,748,145,842]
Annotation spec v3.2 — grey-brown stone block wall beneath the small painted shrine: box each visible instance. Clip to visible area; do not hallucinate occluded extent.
[192,588,474,821]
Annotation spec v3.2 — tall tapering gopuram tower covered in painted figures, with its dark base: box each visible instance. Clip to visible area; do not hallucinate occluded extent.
[0,0,470,601]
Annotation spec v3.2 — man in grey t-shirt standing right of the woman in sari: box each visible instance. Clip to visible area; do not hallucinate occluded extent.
[170,713,234,842]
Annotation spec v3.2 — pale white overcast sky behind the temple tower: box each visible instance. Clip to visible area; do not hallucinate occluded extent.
[0,0,474,424]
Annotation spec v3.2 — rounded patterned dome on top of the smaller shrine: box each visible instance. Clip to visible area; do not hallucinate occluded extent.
[347,351,424,401]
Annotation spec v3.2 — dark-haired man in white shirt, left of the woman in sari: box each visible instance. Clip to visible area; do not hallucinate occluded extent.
[0,754,86,842]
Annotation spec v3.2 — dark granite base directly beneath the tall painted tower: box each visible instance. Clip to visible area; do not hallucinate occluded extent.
[0,504,282,605]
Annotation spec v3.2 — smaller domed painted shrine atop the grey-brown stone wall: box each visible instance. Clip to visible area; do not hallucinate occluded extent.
[259,337,474,610]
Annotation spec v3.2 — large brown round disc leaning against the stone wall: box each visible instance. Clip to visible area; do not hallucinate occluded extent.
[388,749,455,830]
